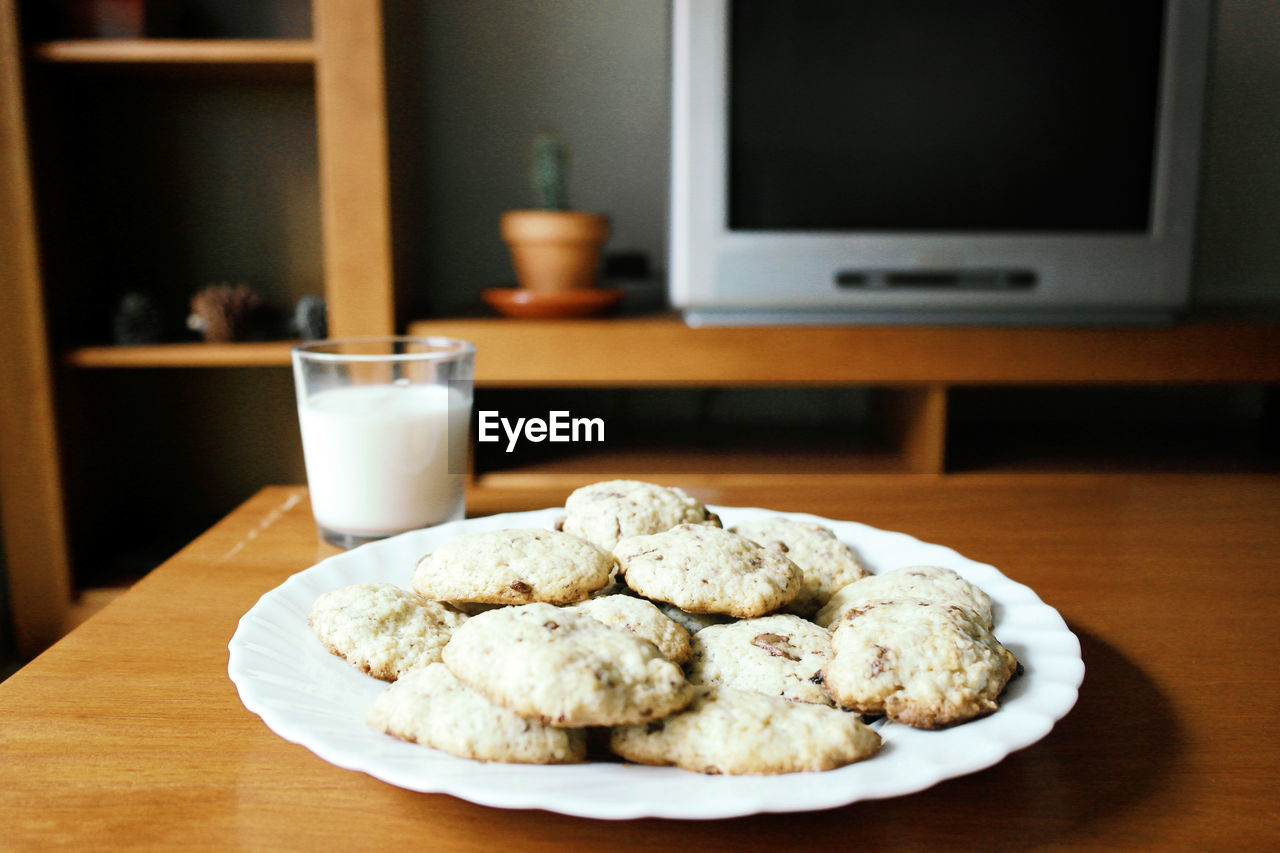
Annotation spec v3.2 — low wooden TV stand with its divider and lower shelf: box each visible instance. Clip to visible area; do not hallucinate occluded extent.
[410,315,1280,488]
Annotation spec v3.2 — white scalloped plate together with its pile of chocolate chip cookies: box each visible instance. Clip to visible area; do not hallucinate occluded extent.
[228,480,1084,820]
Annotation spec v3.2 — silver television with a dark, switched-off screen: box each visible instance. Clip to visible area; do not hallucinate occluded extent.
[669,0,1210,325]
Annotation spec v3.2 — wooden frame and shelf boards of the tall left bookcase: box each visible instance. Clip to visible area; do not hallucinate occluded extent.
[0,0,396,654]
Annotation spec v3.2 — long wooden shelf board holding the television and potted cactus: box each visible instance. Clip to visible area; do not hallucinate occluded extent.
[408,315,1280,387]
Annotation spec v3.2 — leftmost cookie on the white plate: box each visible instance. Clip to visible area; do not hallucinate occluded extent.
[307,584,467,681]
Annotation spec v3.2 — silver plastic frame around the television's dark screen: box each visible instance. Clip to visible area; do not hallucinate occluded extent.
[669,0,1211,325]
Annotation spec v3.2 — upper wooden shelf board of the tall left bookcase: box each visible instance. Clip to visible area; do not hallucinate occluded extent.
[31,38,316,65]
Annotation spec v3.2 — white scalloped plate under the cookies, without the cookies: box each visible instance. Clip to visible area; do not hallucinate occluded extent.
[228,507,1084,820]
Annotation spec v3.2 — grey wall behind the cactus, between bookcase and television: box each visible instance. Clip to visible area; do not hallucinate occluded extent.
[385,0,671,315]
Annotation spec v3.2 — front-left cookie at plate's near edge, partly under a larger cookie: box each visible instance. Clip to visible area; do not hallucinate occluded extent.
[366,663,586,765]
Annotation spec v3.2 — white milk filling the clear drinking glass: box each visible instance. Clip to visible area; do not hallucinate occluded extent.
[298,384,471,537]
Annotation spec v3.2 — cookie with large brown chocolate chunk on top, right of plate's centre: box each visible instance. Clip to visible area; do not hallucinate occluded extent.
[685,613,832,704]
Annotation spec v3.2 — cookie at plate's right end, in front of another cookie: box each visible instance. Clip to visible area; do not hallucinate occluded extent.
[819,598,1018,729]
